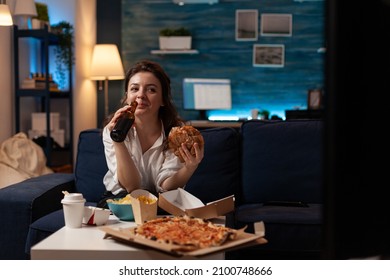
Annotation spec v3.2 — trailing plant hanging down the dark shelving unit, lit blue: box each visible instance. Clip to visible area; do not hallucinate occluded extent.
[51,21,74,88]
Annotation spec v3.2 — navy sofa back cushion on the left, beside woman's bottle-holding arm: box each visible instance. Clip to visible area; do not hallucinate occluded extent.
[75,129,108,202]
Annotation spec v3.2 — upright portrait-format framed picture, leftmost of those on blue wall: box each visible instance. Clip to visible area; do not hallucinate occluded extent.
[236,10,258,41]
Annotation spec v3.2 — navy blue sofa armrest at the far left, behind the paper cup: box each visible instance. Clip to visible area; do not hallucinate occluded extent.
[0,173,75,259]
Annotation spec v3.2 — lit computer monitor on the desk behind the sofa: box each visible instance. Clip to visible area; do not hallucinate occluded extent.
[183,78,232,110]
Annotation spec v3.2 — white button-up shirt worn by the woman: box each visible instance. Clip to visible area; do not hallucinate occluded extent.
[103,124,183,194]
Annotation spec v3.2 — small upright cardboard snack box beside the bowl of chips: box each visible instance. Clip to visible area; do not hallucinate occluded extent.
[130,189,157,225]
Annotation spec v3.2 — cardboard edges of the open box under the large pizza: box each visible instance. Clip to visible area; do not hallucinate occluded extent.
[100,222,268,257]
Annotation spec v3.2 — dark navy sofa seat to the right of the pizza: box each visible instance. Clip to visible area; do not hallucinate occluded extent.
[227,204,323,259]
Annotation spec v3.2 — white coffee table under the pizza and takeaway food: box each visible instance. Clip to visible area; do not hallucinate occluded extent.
[31,215,225,260]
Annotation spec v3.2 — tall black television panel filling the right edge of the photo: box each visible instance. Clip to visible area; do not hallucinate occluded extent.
[322,0,390,259]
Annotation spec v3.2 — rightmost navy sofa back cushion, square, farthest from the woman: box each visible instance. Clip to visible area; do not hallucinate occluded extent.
[241,120,323,203]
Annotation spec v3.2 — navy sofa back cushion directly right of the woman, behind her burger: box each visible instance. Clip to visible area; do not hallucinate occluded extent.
[185,127,240,203]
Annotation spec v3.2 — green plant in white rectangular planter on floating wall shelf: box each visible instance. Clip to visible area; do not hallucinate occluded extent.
[159,27,192,50]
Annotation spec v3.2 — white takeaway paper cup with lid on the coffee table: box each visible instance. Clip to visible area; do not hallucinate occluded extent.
[61,193,85,228]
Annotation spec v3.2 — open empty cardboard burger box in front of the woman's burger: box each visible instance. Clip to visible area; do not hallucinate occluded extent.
[158,188,234,219]
